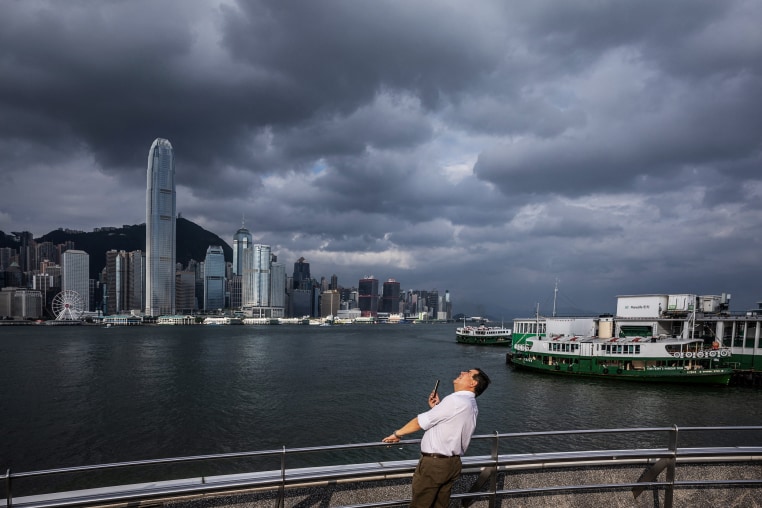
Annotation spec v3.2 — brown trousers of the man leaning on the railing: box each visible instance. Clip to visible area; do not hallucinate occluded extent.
[410,455,461,508]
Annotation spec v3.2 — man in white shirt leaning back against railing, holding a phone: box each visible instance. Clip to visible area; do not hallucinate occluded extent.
[383,369,489,508]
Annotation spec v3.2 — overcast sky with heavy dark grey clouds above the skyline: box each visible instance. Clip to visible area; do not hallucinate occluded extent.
[0,0,762,319]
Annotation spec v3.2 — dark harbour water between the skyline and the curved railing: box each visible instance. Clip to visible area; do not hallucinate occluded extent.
[0,325,762,471]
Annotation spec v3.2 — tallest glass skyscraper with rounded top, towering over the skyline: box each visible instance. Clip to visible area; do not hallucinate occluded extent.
[146,138,177,316]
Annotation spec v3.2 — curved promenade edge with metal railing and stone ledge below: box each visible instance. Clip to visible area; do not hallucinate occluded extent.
[0,426,762,508]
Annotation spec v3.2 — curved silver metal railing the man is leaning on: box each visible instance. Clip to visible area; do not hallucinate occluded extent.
[0,425,762,508]
